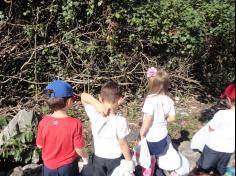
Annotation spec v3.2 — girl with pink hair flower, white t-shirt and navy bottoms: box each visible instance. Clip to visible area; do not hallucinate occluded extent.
[140,67,177,175]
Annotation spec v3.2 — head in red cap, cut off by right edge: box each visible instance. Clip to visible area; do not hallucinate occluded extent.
[222,83,235,108]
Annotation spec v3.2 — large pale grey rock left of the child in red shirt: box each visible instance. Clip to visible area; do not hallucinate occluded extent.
[0,110,38,146]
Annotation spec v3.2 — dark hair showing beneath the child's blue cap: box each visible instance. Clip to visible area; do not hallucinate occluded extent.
[44,90,70,111]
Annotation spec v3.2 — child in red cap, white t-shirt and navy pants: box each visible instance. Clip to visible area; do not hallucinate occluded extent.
[197,84,235,175]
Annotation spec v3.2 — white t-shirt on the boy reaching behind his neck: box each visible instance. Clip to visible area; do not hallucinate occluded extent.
[85,105,130,159]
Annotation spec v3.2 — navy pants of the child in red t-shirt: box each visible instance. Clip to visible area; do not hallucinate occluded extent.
[43,160,79,176]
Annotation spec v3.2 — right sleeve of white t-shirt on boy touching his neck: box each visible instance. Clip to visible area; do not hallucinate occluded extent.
[117,117,130,139]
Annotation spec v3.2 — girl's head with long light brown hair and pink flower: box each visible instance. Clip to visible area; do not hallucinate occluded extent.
[147,67,170,95]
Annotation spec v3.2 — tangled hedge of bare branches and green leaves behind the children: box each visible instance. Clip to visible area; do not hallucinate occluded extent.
[0,0,235,106]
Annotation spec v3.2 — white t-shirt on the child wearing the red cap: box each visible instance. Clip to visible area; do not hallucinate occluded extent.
[206,109,235,153]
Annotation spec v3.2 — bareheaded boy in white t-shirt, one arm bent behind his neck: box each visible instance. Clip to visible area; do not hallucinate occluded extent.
[81,81,134,176]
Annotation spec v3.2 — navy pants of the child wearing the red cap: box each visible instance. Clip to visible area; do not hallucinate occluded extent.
[197,146,232,175]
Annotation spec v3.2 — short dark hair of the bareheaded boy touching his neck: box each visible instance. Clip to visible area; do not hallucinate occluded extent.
[100,81,122,104]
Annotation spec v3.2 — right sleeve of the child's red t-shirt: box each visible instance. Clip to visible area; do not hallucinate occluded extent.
[74,120,85,149]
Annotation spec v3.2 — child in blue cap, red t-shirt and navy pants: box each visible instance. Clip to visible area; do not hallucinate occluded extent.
[36,80,88,176]
